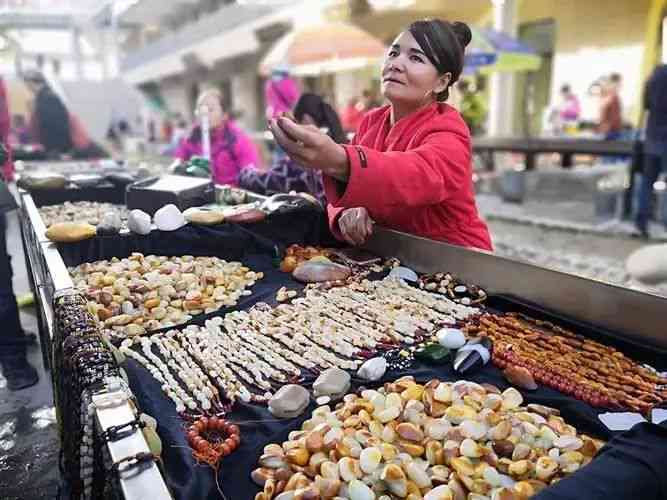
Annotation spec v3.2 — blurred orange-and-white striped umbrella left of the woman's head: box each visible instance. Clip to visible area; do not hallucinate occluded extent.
[259,23,386,76]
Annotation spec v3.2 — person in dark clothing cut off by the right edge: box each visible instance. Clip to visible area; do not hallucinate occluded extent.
[635,64,667,238]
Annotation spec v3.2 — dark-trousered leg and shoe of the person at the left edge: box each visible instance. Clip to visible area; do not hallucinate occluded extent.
[0,214,38,390]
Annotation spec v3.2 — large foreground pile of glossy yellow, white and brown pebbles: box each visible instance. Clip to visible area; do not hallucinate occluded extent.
[251,377,604,500]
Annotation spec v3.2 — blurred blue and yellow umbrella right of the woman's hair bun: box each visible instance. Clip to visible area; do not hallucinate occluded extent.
[465,27,542,73]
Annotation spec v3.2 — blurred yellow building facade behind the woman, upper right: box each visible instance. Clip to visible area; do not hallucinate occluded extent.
[332,0,667,135]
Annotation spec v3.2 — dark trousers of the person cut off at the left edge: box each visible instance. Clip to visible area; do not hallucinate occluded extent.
[0,214,26,360]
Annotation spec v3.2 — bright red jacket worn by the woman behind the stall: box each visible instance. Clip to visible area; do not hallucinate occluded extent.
[324,103,493,250]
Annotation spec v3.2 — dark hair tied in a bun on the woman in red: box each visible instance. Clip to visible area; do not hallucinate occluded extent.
[408,19,472,102]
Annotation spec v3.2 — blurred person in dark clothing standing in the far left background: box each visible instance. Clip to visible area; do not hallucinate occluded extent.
[23,71,73,155]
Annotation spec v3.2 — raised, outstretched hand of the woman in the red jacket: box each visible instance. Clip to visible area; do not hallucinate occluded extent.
[269,116,350,182]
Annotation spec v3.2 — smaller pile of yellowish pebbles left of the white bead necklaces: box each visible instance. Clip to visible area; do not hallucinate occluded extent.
[69,253,264,340]
